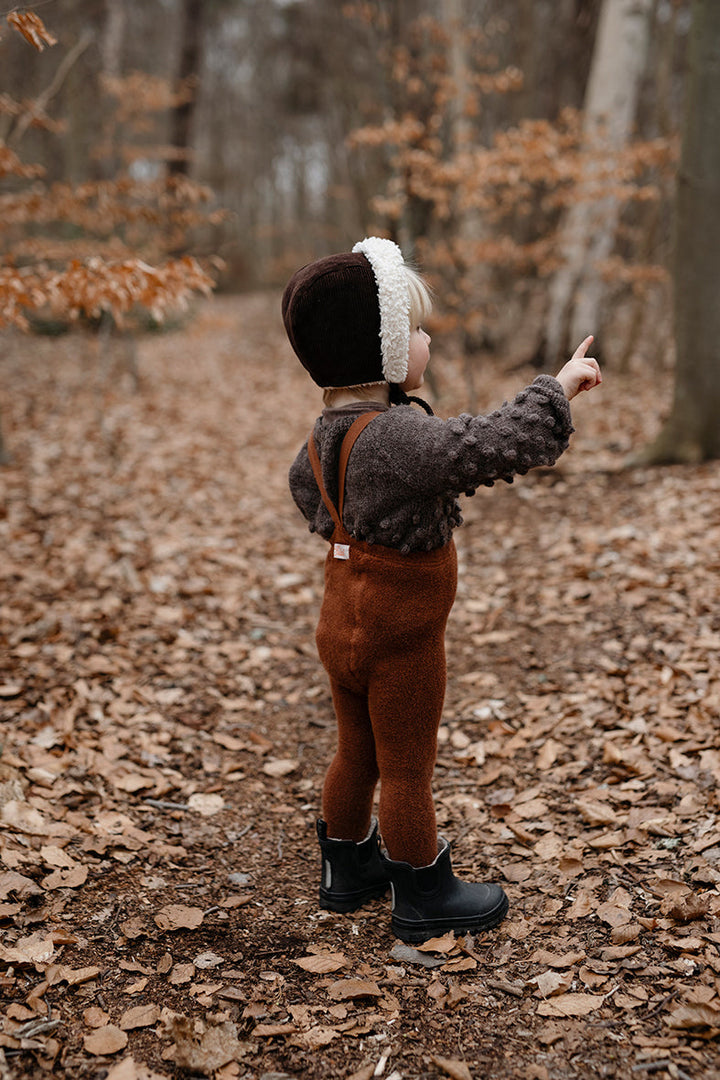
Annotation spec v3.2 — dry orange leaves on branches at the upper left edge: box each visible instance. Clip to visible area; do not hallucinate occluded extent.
[0,12,222,328]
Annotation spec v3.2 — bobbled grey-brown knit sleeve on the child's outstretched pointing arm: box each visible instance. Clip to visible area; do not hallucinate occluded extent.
[366,375,574,496]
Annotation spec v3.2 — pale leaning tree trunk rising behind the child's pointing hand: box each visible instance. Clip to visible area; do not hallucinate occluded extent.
[546,0,651,364]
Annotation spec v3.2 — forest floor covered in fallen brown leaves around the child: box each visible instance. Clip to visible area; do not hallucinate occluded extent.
[0,295,720,1080]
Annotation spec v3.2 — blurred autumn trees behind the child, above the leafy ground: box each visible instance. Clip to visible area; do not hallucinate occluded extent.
[0,0,718,459]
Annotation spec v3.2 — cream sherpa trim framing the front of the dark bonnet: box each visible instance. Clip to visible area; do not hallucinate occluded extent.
[353,237,410,382]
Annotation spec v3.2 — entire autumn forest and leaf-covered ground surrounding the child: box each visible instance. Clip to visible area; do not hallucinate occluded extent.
[7,10,720,1080]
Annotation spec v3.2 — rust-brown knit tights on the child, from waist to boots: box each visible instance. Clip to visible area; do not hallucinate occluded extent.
[317,542,456,866]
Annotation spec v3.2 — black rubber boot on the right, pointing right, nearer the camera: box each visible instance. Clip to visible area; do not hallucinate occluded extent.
[385,838,507,944]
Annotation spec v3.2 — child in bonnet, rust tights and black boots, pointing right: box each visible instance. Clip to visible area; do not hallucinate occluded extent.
[283,237,601,942]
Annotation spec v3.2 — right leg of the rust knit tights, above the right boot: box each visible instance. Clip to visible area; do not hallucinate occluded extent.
[369,642,446,866]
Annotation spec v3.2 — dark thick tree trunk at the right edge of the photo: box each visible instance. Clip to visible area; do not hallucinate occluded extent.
[631,0,720,464]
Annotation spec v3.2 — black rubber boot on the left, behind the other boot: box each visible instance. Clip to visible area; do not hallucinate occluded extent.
[317,818,390,912]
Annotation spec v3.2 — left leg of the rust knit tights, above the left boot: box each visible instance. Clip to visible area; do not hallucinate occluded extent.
[323,678,379,838]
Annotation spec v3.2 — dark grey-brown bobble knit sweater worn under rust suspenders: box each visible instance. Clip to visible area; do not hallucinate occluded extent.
[289,375,574,554]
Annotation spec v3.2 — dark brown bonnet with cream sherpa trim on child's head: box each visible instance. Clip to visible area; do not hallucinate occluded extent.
[283,237,410,389]
